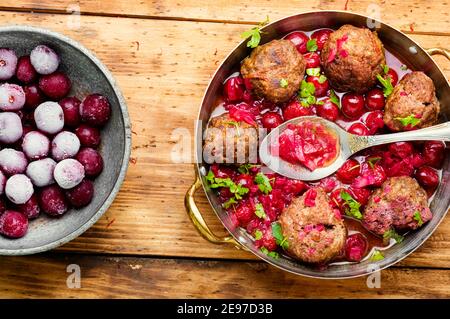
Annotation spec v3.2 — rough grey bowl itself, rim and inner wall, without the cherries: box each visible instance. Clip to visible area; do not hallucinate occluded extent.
[0,26,131,255]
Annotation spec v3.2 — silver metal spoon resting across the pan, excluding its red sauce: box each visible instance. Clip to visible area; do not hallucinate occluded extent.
[259,116,450,181]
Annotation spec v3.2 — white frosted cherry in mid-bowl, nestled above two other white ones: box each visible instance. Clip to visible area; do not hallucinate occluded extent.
[34,102,64,134]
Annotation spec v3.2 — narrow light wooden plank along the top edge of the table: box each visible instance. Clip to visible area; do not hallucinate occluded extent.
[0,0,450,33]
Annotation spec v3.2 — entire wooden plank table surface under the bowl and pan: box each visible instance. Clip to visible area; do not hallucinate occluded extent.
[0,0,450,298]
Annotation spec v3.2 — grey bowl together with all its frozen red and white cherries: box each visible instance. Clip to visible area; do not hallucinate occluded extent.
[0,27,130,255]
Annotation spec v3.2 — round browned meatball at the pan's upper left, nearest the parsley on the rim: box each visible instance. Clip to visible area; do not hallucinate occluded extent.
[241,40,306,103]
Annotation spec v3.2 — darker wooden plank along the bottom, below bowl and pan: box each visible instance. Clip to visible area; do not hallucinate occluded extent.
[0,255,450,299]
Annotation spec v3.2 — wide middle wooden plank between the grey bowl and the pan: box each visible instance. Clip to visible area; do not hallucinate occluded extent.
[0,12,450,267]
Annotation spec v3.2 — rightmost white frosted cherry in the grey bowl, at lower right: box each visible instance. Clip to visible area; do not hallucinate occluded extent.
[53,158,84,189]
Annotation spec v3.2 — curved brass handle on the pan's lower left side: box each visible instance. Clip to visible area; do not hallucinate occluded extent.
[184,174,243,249]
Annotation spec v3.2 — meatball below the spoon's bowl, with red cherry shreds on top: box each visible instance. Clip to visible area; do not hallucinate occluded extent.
[279,188,347,264]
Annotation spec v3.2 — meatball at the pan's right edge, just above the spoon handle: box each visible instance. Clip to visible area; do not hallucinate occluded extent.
[383,72,440,131]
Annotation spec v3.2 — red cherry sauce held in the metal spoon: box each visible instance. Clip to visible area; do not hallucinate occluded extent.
[271,121,339,171]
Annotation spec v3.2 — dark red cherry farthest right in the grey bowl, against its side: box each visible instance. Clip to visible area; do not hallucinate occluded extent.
[80,94,111,126]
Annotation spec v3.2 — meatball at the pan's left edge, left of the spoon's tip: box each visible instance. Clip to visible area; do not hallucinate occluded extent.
[203,113,259,164]
